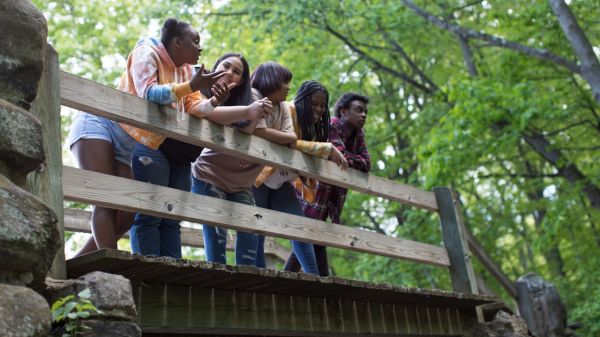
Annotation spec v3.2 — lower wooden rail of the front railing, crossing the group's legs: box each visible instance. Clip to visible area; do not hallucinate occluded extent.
[63,166,449,267]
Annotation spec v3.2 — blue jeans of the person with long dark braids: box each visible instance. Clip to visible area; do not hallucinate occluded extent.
[252,182,319,275]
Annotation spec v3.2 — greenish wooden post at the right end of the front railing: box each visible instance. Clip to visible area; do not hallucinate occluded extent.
[433,187,479,294]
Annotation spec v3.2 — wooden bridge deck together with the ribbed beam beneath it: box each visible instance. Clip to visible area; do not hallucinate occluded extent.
[68,249,497,336]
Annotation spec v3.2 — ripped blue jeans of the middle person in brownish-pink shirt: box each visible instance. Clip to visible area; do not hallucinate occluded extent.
[192,177,258,266]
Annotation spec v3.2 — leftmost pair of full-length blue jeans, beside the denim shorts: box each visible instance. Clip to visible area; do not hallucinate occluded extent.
[129,143,191,259]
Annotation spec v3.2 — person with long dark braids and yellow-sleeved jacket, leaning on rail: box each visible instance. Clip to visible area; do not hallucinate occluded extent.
[253,81,348,275]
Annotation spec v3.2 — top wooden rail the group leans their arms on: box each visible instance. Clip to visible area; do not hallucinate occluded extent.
[60,72,438,211]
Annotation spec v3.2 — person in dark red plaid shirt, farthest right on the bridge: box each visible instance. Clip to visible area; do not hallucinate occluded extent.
[284,92,371,276]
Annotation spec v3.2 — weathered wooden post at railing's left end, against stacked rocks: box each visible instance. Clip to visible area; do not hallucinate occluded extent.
[27,45,67,279]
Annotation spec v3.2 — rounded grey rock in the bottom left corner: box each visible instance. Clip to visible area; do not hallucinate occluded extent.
[0,284,51,337]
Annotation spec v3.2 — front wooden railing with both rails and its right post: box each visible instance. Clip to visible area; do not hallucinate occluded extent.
[52,68,477,293]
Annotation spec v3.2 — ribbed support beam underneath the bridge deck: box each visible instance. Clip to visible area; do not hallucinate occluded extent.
[132,282,477,336]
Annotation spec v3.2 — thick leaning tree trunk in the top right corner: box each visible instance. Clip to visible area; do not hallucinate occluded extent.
[549,0,600,103]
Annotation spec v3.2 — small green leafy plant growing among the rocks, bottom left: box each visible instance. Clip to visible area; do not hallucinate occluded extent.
[50,288,102,337]
